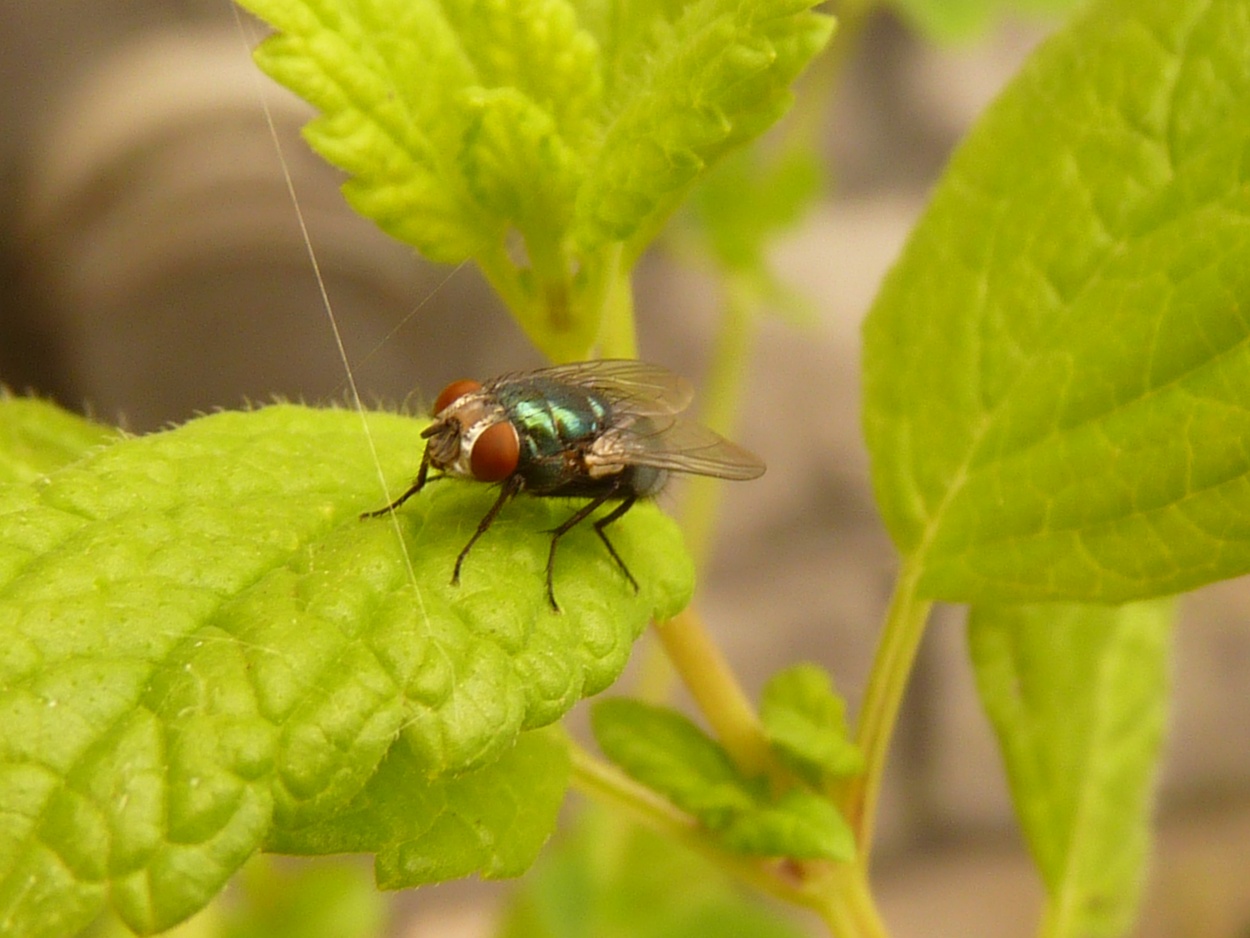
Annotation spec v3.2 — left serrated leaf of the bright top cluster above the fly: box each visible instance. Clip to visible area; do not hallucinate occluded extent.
[241,0,503,264]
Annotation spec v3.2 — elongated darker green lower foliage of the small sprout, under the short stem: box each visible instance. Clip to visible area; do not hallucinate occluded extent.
[591,698,855,860]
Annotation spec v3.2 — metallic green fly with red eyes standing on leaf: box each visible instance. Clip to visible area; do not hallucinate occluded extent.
[361,359,764,612]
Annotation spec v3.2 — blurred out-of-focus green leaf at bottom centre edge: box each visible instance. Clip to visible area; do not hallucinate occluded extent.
[499,807,808,938]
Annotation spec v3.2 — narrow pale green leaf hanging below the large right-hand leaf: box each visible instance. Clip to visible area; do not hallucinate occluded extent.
[969,600,1173,938]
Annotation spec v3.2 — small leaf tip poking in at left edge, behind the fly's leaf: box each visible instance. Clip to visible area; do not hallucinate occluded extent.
[0,389,120,485]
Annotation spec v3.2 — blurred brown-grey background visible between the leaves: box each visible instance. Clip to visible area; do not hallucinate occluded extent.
[0,0,1250,938]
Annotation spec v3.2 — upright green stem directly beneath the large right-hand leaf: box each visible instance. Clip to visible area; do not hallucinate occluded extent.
[843,565,933,868]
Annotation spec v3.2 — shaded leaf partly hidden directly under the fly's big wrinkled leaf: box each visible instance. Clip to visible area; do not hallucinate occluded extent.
[268,730,569,889]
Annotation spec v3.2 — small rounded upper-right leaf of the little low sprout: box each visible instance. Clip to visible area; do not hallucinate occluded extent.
[760,664,864,789]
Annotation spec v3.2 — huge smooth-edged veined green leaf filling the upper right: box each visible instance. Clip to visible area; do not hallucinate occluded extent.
[864,0,1250,602]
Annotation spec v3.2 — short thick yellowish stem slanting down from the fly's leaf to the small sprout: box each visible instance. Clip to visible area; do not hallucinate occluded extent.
[655,608,771,775]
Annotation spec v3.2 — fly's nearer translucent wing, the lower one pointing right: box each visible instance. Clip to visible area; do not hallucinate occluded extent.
[596,416,765,482]
